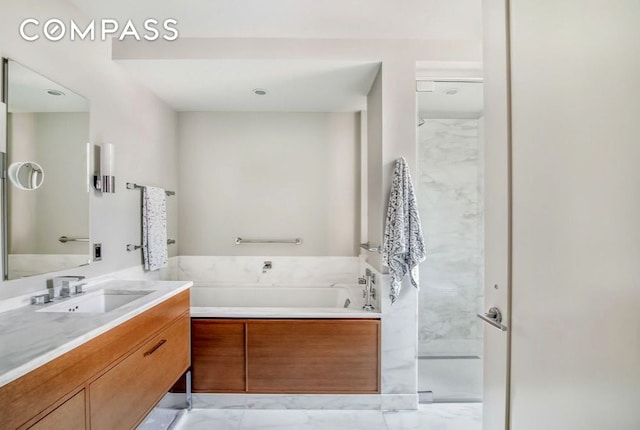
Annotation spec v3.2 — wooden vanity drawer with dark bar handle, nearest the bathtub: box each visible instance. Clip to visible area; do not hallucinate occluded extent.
[89,313,190,430]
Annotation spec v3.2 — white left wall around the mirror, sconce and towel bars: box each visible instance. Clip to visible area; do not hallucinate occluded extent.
[0,0,177,298]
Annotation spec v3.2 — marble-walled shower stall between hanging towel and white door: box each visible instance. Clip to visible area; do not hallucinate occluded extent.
[415,81,484,402]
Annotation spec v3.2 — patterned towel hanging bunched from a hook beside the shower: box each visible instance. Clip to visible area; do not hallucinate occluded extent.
[382,157,426,303]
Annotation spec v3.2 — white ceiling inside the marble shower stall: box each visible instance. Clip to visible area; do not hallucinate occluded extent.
[417,82,484,118]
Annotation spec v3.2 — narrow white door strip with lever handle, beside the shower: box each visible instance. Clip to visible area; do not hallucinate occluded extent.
[482,0,511,430]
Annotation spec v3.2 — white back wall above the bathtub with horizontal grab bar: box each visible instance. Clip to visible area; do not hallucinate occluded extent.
[178,112,360,256]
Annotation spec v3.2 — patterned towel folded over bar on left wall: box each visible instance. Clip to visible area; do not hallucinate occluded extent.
[142,187,168,270]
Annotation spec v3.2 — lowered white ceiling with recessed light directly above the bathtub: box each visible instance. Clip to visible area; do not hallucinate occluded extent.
[117,60,379,112]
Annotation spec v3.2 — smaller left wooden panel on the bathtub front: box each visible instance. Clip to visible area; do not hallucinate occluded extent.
[191,319,246,393]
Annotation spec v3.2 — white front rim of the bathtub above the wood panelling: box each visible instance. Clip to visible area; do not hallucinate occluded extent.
[191,307,381,319]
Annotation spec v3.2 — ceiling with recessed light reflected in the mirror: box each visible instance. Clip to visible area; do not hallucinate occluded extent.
[8,61,89,113]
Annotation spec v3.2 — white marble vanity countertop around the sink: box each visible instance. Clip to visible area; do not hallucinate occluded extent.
[0,280,193,386]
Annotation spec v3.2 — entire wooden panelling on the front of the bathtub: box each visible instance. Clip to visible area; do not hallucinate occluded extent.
[192,318,380,394]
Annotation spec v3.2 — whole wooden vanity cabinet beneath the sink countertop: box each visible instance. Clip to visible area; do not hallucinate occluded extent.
[0,290,190,430]
